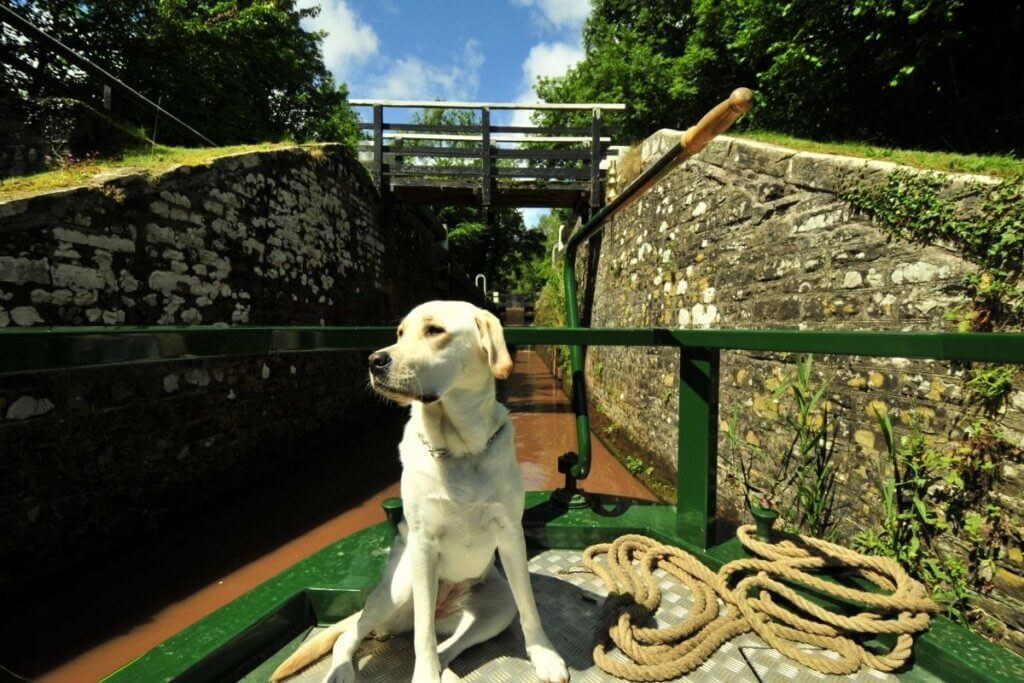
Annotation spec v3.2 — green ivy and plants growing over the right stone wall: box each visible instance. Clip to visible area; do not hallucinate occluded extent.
[843,170,1024,623]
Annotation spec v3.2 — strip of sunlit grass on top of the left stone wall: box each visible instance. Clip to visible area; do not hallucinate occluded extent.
[0,142,295,201]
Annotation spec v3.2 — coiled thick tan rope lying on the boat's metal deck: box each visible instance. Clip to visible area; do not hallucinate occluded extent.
[582,524,938,681]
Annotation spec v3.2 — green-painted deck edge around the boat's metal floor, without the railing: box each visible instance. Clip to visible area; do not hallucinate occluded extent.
[104,492,1024,683]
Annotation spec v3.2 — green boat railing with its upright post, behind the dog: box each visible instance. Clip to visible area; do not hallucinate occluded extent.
[0,327,1024,549]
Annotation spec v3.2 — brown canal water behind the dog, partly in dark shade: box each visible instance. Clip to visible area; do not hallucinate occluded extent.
[0,350,654,683]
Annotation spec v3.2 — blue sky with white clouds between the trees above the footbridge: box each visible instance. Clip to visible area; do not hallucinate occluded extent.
[299,0,590,223]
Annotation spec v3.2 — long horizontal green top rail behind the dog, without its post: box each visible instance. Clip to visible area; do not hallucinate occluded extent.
[0,326,1024,376]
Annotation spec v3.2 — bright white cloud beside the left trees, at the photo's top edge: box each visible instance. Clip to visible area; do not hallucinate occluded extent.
[298,0,380,82]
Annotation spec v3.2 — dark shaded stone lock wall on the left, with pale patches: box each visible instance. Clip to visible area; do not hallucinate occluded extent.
[0,145,481,592]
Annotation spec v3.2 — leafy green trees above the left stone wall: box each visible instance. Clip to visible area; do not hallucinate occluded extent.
[0,0,357,144]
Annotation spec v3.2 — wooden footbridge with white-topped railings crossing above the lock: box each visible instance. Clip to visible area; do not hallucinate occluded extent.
[349,99,626,213]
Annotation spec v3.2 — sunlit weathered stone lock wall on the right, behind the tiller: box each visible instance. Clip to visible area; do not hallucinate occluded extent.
[580,131,1024,652]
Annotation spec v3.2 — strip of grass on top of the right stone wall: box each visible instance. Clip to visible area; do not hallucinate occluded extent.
[728,130,1024,178]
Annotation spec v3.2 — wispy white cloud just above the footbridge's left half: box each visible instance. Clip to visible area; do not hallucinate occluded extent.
[370,40,483,99]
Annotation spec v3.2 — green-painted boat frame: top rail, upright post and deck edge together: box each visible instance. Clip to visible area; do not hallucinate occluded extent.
[6,327,1024,681]
